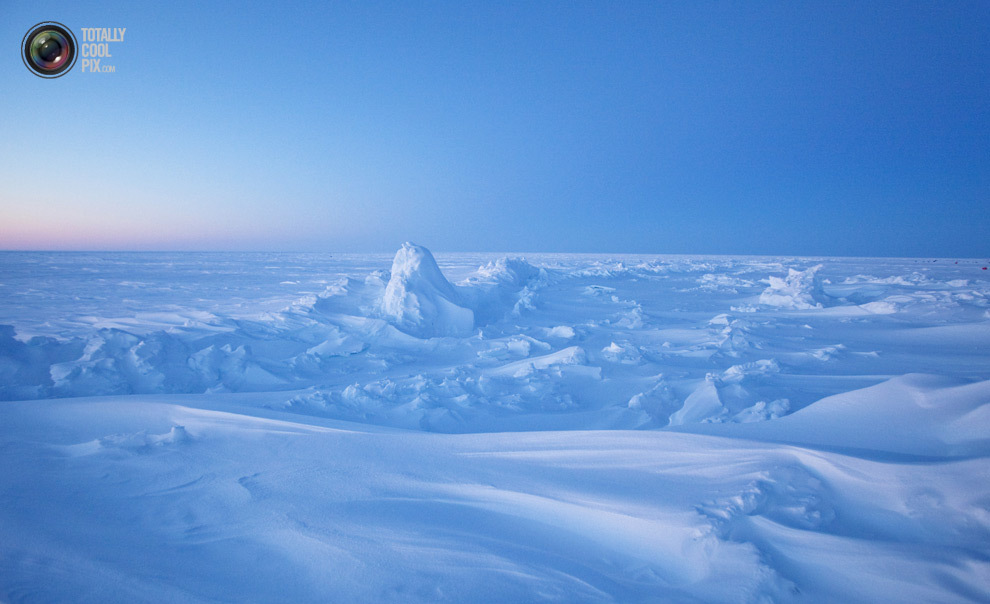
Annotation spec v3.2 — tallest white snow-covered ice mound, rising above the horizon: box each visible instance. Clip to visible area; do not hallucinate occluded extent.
[381,242,474,338]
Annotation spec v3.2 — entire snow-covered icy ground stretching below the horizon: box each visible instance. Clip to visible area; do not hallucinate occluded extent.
[0,244,990,602]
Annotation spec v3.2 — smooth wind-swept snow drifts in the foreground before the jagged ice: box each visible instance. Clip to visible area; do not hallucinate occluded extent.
[0,390,990,602]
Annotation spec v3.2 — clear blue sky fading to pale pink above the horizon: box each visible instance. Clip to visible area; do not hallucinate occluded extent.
[0,0,990,256]
